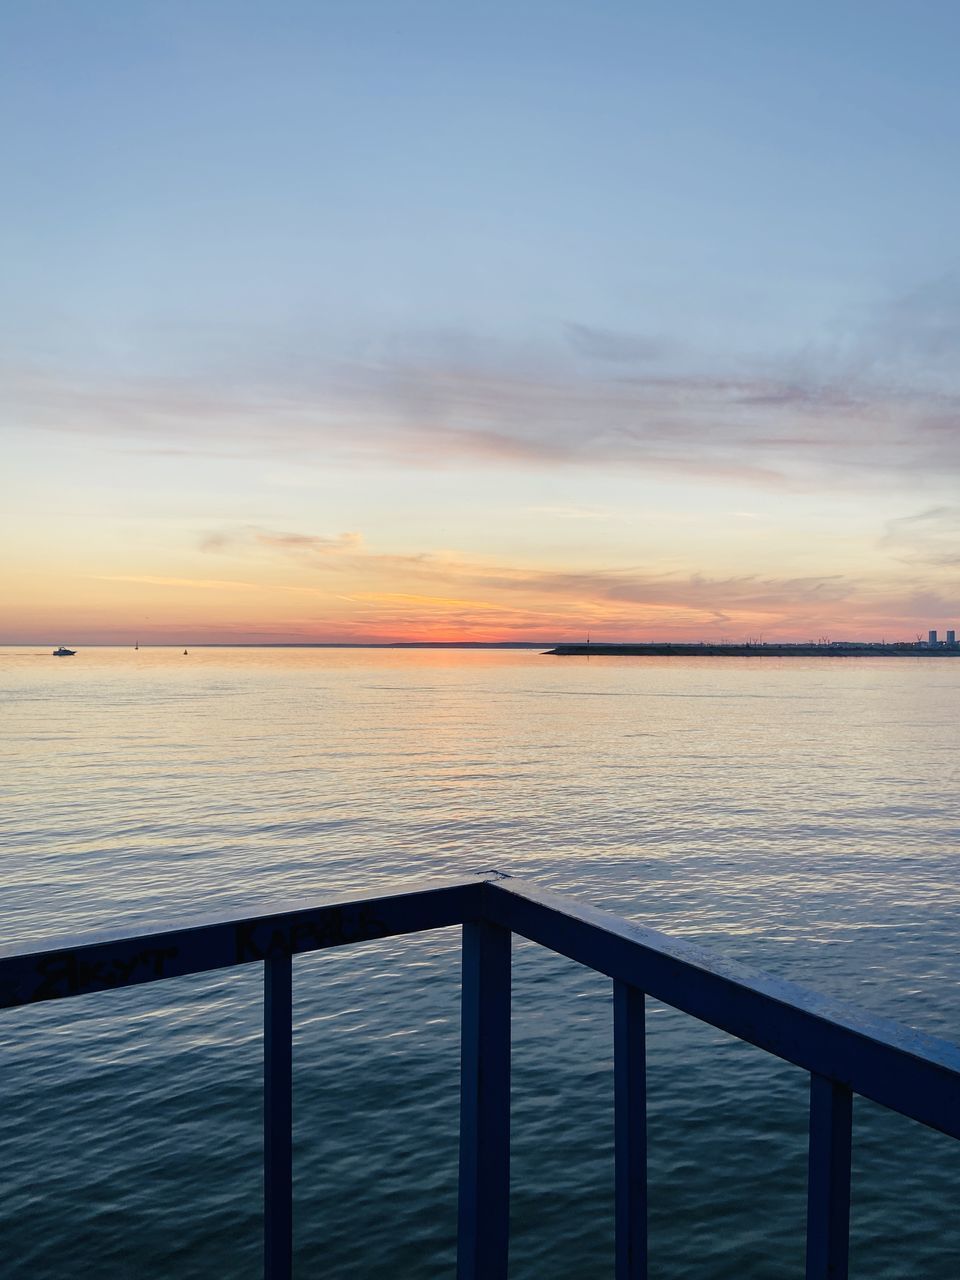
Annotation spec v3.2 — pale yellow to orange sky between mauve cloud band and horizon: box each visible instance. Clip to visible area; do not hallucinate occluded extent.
[0,412,956,644]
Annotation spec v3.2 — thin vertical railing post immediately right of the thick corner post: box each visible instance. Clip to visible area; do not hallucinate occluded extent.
[613,982,646,1280]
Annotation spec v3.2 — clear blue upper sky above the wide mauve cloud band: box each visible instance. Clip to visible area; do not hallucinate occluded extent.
[11,0,960,364]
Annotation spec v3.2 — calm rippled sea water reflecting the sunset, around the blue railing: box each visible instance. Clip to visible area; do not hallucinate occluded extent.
[0,648,960,1280]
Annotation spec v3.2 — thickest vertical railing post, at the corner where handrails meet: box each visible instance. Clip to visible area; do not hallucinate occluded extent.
[457,920,511,1280]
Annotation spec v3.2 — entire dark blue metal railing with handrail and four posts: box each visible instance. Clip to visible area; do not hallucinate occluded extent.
[0,872,960,1280]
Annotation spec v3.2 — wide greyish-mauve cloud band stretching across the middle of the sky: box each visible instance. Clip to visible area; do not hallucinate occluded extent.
[9,302,960,491]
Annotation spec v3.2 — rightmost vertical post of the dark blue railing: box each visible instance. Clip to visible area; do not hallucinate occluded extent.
[806,1073,854,1280]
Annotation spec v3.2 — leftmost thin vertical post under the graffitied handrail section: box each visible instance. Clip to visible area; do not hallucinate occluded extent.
[264,956,293,1280]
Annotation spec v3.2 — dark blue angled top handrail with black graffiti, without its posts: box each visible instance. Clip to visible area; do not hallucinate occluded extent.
[0,872,960,1138]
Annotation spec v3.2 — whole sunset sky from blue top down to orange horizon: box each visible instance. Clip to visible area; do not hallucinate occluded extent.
[0,0,960,645]
